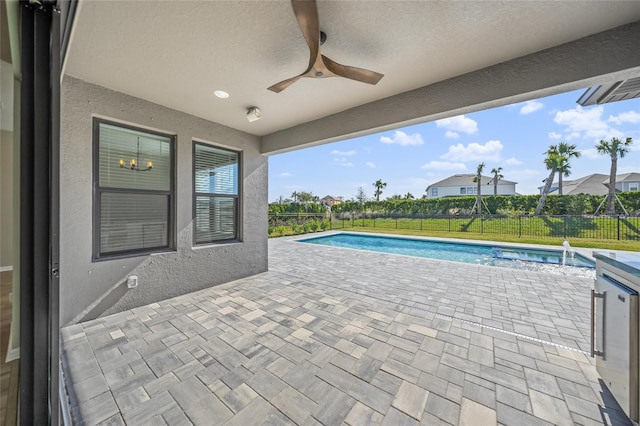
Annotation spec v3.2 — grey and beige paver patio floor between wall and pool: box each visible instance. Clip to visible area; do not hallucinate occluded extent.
[62,238,631,425]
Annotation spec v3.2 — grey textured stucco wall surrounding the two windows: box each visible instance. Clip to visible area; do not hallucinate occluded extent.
[60,76,268,325]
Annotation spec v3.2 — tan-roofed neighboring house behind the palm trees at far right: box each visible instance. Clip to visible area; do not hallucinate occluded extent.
[538,173,640,195]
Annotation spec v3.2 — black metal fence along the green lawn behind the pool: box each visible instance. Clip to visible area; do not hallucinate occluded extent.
[269,212,640,241]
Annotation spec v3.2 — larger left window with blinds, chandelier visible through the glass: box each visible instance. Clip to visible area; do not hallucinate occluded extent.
[93,118,174,259]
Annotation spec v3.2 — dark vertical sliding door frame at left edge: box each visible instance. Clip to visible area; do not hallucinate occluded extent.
[19,0,60,425]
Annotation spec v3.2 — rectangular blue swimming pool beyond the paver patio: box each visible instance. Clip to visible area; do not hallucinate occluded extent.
[298,233,595,277]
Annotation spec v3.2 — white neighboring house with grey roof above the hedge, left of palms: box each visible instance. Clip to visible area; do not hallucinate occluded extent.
[427,173,517,198]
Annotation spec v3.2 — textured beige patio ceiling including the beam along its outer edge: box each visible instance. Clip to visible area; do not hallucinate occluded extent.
[64,0,640,154]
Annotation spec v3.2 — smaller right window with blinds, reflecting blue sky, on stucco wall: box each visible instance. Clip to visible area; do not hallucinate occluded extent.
[193,142,240,244]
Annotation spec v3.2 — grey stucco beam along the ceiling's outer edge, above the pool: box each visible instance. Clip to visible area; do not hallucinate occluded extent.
[261,21,640,155]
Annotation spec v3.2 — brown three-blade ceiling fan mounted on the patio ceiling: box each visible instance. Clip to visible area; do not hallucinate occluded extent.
[269,0,384,93]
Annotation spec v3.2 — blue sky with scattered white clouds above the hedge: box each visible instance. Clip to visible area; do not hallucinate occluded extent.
[269,90,640,202]
